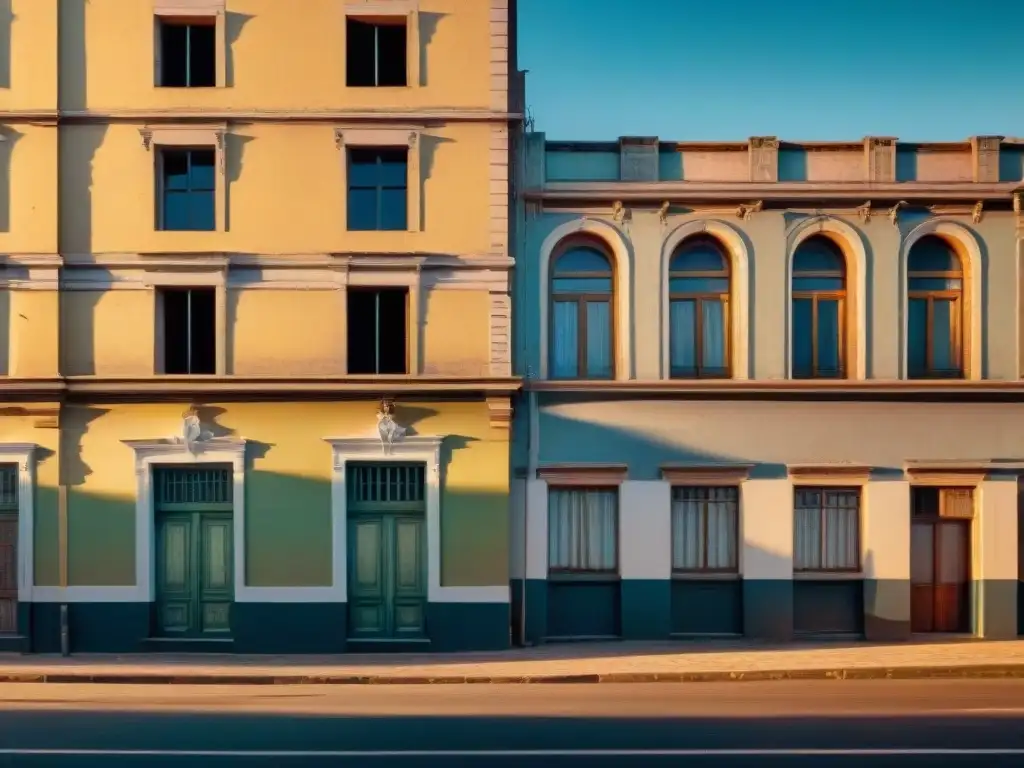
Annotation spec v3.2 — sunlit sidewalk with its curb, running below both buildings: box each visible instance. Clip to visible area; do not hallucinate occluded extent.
[0,639,1024,685]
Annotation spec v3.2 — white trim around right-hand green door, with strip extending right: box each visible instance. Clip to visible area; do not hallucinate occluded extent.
[324,434,509,603]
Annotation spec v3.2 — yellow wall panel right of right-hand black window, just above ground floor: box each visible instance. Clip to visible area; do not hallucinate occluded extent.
[423,290,490,376]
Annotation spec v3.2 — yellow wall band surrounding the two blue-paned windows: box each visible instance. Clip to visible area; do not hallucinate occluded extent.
[60,124,490,254]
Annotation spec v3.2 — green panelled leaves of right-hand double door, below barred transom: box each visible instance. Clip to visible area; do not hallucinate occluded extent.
[348,514,427,640]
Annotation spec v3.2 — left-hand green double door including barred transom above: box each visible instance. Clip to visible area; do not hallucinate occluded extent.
[154,466,234,638]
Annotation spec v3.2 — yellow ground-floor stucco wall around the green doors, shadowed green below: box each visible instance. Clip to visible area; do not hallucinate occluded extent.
[37,402,508,587]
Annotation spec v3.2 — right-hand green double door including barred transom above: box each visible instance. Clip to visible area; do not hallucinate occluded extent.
[348,464,427,640]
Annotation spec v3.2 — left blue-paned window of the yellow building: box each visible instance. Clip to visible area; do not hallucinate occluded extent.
[160,148,217,231]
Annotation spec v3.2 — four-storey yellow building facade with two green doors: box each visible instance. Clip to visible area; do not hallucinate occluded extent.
[0,0,520,652]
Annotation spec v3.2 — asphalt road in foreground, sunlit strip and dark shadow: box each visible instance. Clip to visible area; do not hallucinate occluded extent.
[0,680,1024,768]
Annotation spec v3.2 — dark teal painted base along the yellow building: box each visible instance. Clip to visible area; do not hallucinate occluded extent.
[28,603,510,654]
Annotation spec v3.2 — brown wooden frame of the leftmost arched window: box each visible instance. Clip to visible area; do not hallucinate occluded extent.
[547,238,618,381]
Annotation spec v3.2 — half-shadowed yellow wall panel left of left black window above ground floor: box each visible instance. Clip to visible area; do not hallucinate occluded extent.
[61,290,156,376]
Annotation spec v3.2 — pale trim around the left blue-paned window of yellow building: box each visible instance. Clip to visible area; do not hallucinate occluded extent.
[139,124,227,237]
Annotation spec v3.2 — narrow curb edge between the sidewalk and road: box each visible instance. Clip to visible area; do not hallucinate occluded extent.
[0,664,1024,685]
